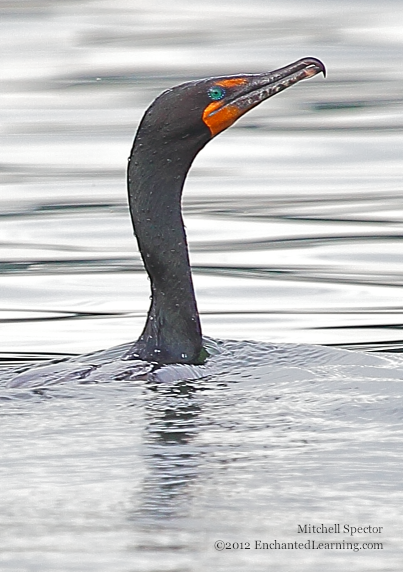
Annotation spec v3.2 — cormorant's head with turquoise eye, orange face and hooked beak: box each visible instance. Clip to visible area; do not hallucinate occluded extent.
[140,58,326,148]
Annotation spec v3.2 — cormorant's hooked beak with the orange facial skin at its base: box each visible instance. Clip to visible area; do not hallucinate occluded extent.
[203,58,326,137]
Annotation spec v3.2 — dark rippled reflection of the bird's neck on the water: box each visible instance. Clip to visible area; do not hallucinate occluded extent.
[130,380,202,525]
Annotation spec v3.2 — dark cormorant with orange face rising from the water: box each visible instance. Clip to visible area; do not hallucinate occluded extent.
[126,58,325,364]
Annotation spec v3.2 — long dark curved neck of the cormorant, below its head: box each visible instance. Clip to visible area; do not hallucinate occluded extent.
[126,120,207,363]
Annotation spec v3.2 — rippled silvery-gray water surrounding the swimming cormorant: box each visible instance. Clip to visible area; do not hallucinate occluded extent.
[0,0,403,572]
